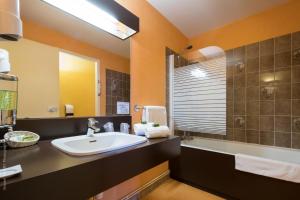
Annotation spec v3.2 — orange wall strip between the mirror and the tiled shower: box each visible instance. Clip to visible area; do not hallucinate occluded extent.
[118,0,188,123]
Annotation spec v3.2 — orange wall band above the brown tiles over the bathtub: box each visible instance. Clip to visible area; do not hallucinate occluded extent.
[190,0,300,50]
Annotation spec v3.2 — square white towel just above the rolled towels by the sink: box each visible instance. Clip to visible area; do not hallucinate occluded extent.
[142,106,167,126]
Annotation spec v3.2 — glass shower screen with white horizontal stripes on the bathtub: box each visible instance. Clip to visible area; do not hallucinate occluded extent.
[168,47,226,138]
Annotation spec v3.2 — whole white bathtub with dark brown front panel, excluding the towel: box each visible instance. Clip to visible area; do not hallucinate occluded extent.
[170,137,300,200]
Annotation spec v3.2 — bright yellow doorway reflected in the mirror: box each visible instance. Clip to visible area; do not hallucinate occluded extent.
[59,51,100,117]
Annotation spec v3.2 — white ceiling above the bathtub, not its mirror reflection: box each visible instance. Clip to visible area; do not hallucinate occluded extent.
[148,0,288,38]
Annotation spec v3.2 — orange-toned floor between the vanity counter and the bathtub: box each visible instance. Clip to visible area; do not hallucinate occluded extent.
[142,179,223,200]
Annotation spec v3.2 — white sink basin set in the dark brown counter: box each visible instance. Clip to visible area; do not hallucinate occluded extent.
[51,132,147,156]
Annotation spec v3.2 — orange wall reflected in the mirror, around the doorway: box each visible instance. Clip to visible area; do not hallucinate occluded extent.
[22,19,130,115]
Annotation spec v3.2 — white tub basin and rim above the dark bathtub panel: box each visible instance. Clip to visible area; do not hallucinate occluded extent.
[181,137,300,164]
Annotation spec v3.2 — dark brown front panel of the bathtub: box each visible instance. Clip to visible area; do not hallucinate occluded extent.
[170,141,300,200]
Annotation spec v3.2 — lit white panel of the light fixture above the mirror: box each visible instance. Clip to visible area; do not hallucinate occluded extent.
[42,0,138,40]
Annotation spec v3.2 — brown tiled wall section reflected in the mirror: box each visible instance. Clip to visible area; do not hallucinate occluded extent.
[106,69,130,115]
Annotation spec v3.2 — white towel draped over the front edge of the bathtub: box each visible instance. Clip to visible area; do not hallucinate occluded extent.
[235,154,300,183]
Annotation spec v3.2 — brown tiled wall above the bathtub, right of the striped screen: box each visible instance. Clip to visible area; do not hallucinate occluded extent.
[169,32,300,149]
